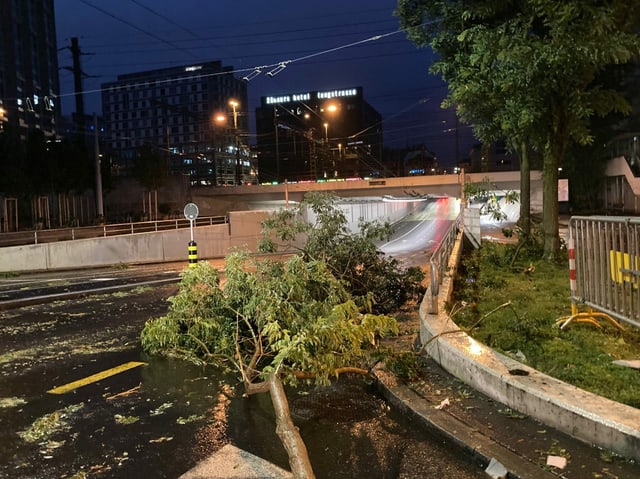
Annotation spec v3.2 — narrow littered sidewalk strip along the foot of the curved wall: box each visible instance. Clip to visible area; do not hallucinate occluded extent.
[376,304,640,479]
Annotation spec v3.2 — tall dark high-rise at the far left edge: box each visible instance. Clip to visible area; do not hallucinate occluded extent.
[0,0,60,139]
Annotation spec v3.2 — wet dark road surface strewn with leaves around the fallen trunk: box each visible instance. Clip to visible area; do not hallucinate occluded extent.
[0,271,482,479]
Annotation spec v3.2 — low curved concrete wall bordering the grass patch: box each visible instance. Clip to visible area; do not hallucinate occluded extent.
[420,232,640,460]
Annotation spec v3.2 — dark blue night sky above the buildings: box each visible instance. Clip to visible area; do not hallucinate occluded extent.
[55,0,472,165]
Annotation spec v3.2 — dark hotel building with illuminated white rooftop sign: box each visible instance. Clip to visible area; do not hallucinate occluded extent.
[256,87,386,182]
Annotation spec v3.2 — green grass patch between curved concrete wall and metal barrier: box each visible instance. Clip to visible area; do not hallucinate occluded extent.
[449,243,640,408]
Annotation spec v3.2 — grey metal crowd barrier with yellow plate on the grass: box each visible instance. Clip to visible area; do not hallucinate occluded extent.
[569,216,640,327]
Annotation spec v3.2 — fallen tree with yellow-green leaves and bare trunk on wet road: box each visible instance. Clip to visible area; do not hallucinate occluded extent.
[141,193,422,479]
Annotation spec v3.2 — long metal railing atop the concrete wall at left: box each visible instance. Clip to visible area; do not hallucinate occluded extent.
[0,216,228,247]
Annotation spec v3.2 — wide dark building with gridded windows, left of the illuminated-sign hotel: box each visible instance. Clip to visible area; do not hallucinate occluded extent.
[102,61,256,186]
